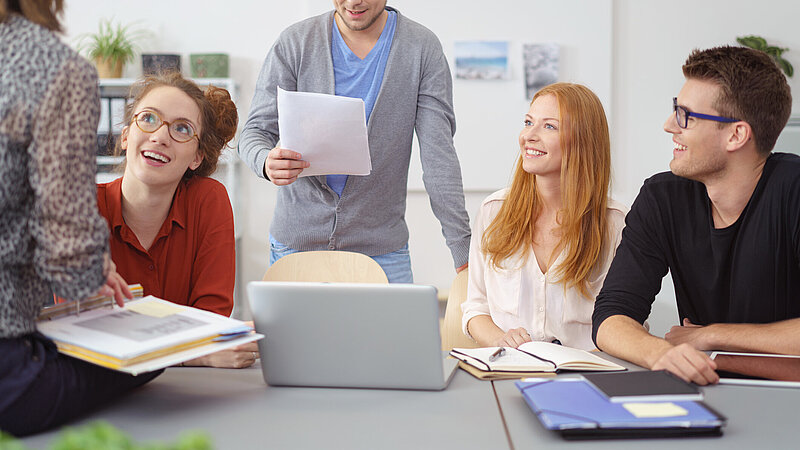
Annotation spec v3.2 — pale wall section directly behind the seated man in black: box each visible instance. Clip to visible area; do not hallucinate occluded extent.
[611,0,800,335]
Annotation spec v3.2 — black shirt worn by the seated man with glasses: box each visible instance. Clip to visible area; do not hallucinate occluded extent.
[592,153,800,338]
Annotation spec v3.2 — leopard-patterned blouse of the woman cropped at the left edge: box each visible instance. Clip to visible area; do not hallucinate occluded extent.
[0,14,108,338]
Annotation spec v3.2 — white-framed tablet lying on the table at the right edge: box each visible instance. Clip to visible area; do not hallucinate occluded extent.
[711,352,800,388]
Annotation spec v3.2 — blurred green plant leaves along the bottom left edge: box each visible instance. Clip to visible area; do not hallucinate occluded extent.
[0,421,213,450]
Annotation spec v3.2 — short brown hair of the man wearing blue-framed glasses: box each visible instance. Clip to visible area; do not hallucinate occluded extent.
[683,46,792,154]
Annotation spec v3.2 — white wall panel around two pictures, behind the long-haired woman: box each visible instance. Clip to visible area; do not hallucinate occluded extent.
[397,0,612,192]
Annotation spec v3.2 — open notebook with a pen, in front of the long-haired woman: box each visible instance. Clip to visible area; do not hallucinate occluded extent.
[450,341,626,379]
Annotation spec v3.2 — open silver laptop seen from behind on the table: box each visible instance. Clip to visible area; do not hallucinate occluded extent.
[247,281,457,390]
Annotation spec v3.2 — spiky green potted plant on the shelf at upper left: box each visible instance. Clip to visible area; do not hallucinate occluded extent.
[78,20,141,78]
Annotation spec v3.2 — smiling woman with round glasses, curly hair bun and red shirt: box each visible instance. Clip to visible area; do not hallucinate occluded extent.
[97,73,257,367]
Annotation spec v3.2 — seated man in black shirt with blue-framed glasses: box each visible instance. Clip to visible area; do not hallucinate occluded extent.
[593,47,800,384]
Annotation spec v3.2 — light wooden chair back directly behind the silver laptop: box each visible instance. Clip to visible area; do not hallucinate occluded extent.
[263,251,389,283]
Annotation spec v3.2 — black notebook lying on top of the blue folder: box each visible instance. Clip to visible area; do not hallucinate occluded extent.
[583,370,703,403]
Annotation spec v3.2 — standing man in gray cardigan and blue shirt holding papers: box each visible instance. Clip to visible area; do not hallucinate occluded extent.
[239,0,470,283]
